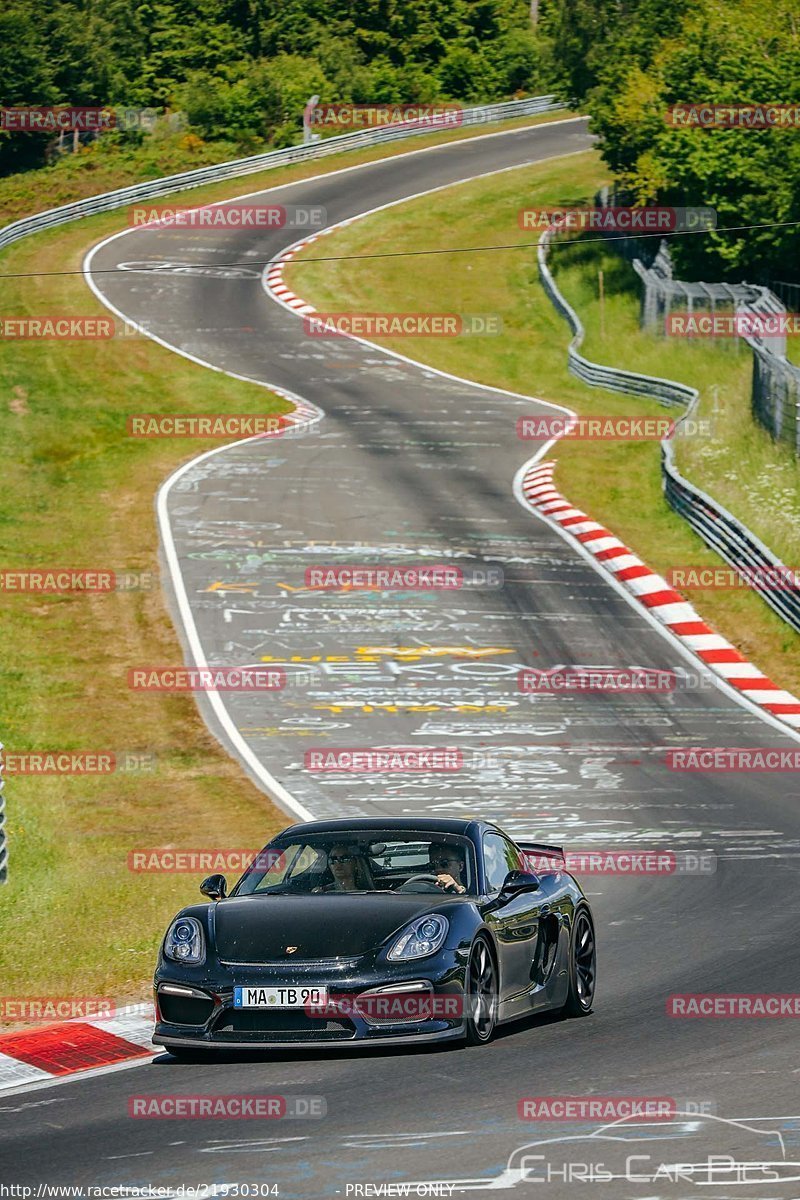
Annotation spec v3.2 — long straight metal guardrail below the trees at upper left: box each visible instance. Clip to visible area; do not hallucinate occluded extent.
[0,96,566,248]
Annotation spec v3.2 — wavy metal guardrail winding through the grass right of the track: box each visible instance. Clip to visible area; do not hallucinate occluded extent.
[537,229,800,632]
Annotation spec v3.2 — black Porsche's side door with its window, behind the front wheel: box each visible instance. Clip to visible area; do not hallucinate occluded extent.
[483,830,541,1018]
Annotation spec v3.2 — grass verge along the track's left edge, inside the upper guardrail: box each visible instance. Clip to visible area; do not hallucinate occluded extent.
[0,110,575,1012]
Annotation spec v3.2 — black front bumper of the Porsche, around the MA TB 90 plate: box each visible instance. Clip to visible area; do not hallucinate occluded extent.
[152,950,464,1050]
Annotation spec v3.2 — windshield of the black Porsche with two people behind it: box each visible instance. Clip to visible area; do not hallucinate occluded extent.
[233,829,476,895]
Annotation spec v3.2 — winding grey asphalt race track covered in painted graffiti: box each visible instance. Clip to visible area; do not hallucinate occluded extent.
[0,122,800,1198]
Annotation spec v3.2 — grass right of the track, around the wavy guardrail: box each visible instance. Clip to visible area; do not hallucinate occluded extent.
[287,152,800,689]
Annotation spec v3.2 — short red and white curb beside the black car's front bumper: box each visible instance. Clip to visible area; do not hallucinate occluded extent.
[0,1004,155,1094]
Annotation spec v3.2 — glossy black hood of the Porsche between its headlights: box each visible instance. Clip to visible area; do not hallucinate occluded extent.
[213,893,447,962]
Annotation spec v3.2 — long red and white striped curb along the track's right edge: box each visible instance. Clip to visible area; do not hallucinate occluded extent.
[522,462,800,728]
